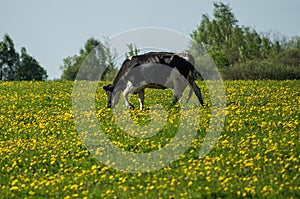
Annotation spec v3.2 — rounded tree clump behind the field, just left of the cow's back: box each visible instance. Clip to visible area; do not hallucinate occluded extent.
[60,38,117,80]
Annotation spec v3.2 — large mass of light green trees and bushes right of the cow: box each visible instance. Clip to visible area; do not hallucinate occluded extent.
[191,2,300,79]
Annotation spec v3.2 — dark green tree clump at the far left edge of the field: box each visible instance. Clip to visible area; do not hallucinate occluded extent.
[0,34,48,81]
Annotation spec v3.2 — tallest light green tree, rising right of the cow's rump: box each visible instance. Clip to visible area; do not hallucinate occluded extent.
[191,3,241,68]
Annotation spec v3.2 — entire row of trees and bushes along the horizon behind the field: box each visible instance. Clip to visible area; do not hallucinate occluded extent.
[0,2,300,81]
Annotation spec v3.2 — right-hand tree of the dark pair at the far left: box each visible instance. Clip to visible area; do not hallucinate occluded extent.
[16,47,48,81]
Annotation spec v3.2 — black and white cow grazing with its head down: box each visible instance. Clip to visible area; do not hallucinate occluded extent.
[103,52,204,110]
